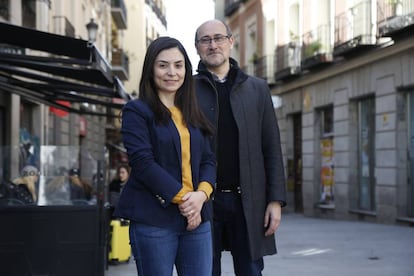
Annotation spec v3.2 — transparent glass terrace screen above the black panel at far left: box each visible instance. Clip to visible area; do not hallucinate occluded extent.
[0,146,101,206]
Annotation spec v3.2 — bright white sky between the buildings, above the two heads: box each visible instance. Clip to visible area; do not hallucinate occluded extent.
[166,0,214,69]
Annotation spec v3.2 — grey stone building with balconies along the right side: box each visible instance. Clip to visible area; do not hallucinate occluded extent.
[220,0,414,224]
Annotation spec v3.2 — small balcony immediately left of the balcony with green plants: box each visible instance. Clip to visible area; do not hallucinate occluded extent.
[274,41,302,81]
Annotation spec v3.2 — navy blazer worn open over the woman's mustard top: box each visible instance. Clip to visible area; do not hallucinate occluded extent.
[114,100,216,229]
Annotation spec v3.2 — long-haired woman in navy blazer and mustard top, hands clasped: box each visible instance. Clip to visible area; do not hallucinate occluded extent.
[114,37,215,276]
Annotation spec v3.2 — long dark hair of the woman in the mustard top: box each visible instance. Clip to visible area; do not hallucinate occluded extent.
[139,36,213,135]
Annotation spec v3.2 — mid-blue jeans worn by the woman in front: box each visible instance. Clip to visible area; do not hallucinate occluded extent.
[129,222,213,276]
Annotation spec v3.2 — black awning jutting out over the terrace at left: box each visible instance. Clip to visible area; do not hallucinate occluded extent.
[0,23,130,116]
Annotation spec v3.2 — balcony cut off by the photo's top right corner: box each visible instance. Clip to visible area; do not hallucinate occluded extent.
[377,0,414,37]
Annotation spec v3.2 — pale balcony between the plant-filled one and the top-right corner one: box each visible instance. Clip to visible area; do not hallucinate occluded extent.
[334,0,376,55]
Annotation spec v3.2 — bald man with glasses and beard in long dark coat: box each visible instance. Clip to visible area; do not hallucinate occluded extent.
[195,20,286,276]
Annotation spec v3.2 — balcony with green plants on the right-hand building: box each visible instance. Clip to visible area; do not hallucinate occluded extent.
[301,25,333,69]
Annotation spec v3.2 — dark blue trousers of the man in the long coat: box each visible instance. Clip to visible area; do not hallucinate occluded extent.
[213,192,264,276]
